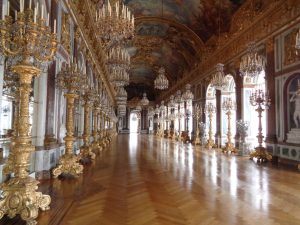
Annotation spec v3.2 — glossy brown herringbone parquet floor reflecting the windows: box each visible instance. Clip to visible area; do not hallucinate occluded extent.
[0,135,300,225]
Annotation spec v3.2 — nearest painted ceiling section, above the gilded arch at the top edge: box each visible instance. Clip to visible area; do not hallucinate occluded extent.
[124,0,245,42]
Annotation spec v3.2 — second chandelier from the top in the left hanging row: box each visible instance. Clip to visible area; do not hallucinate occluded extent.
[107,46,130,71]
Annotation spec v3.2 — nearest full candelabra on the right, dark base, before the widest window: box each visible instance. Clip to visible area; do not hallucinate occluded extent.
[250,89,272,162]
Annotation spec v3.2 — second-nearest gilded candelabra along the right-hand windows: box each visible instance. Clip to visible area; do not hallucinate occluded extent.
[222,98,237,153]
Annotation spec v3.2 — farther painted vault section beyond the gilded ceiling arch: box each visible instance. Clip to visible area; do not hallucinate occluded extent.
[126,18,201,99]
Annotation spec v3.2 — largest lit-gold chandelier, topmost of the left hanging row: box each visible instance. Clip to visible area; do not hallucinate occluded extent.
[96,0,134,47]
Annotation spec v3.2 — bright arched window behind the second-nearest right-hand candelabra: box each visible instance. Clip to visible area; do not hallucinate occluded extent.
[220,74,236,145]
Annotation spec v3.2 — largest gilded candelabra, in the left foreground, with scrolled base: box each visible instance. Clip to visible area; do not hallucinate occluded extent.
[0,4,57,225]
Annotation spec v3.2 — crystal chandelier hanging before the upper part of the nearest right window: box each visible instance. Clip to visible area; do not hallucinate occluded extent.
[240,41,265,77]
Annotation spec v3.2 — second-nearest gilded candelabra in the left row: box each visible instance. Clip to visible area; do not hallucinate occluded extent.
[52,63,84,178]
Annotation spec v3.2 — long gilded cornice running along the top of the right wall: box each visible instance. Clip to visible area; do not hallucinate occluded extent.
[158,0,300,101]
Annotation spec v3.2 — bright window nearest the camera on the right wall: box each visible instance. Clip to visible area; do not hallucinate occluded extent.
[242,71,267,149]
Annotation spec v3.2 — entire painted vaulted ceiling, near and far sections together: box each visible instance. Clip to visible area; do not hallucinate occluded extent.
[119,0,245,100]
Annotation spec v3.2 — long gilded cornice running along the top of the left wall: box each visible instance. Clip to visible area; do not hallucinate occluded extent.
[64,0,115,103]
